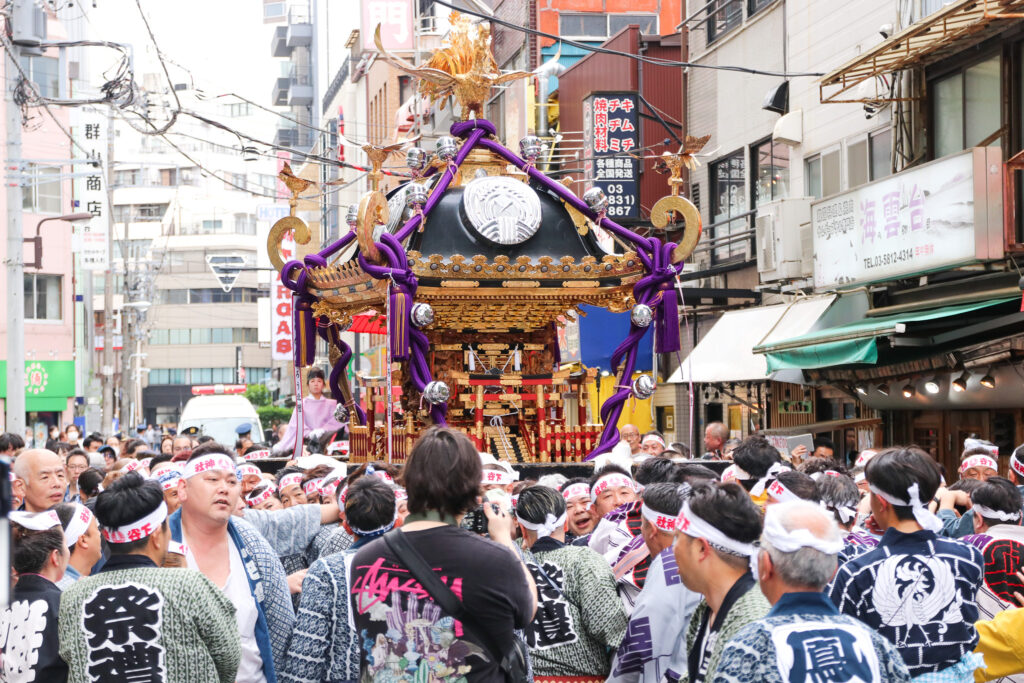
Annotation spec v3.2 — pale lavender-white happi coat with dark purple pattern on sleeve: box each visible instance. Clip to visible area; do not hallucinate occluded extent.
[608,546,700,683]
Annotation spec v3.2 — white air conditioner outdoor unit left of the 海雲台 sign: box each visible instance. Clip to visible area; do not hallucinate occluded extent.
[754,197,812,283]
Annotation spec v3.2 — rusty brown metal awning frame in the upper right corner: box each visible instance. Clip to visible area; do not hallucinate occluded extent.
[819,0,1024,103]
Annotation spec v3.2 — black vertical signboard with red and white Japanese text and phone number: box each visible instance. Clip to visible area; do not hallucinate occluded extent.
[583,92,640,221]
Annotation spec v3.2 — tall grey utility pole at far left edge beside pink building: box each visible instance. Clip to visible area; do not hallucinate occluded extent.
[4,33,25,436]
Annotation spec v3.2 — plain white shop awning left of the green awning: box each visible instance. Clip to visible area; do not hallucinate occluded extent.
[668,295,836,384]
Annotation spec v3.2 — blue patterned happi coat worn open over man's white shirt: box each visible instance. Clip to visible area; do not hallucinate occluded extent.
[167,508,295,683]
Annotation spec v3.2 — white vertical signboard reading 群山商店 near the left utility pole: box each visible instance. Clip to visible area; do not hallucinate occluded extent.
[72,106,111,270]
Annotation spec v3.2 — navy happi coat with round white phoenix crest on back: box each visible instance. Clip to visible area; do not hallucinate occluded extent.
[827,528,983,676]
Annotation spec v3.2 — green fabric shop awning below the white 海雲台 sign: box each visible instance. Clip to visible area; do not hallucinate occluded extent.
[754,297,1020,372]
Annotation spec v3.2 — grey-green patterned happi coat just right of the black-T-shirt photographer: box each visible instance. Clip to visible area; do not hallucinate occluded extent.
[525,537,627,677]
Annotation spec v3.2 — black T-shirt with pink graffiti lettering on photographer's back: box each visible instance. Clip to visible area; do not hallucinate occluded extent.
[349,526,532,683]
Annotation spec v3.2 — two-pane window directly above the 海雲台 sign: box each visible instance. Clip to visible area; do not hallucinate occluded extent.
[931,55,1002,159]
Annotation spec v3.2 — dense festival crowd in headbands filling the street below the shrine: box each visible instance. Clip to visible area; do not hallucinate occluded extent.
[0,425,1024,683]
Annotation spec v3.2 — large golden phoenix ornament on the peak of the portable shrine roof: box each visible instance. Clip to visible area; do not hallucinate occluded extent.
[374,12,532,120]
